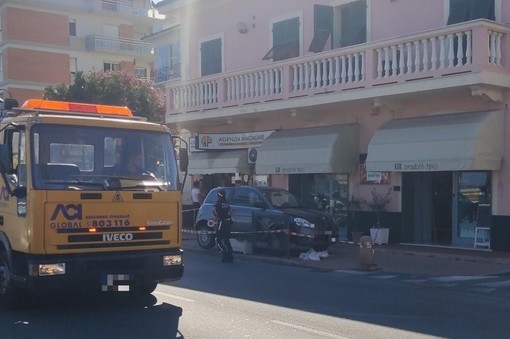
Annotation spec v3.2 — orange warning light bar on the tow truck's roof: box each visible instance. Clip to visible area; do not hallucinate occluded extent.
[21,99,133,117]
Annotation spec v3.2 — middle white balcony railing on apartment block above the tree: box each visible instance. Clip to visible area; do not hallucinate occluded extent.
[85,35,154,55]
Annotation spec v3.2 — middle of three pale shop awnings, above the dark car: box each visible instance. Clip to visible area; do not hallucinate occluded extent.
[255,124,359,174]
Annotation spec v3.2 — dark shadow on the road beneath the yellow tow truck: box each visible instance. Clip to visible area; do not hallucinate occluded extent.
[0,295,182,339]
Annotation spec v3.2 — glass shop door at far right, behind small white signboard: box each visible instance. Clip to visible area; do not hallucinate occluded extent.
[453,171,491,247]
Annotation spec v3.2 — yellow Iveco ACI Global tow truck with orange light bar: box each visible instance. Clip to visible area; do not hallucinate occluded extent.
[0,99,187,307]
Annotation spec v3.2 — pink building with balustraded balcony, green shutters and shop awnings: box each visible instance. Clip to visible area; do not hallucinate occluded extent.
[148,0,510,251]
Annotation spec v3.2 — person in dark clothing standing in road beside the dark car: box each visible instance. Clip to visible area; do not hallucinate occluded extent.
[212,190,234,262]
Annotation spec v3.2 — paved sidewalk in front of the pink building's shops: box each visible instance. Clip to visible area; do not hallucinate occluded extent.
[183,234,510,276]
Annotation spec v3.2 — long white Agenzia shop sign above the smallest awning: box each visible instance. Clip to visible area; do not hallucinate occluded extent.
[195,131,274,150]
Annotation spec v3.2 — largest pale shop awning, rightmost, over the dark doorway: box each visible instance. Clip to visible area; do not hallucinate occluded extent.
[366,111,504,172]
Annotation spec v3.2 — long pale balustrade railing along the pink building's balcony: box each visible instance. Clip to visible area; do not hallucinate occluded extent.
[166,20,510,117]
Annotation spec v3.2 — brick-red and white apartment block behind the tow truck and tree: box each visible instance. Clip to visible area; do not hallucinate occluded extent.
[0,0,155,103]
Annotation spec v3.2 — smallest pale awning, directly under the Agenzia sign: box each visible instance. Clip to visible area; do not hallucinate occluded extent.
[188,149,250,174]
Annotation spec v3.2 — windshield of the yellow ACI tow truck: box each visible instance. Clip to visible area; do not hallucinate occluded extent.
[30,124,178,190]
